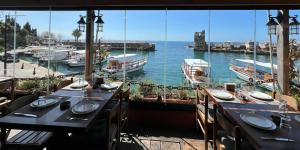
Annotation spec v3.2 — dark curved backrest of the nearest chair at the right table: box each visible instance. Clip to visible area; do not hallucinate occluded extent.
[216,111,236,137]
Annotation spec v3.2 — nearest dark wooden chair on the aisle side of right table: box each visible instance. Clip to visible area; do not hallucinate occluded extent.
[214,108,254,150]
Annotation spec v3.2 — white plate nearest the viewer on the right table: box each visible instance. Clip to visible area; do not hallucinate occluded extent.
[240,113,276,130]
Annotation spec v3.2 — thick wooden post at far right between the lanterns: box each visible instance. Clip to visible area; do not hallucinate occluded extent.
[277,10,289,94]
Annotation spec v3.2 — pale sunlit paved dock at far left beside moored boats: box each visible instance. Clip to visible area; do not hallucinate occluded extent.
[0,60,64,79]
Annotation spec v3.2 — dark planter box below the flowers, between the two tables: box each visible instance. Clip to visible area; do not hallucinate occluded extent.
[128,100,196,130]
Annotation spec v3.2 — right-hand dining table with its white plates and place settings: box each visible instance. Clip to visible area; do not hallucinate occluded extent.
[204,88,300,150]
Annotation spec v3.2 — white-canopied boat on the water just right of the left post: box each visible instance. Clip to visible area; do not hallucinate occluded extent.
[103,54,147,76]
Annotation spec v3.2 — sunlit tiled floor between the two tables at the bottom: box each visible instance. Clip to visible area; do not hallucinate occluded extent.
[121,126,210,150]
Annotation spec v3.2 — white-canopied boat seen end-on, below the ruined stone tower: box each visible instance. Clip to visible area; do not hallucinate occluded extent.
[181,59,210,87]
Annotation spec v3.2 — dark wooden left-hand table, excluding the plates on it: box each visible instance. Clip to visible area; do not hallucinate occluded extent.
[0,82,123,149]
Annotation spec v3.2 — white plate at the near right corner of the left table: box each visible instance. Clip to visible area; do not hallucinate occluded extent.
[71,101,99,115]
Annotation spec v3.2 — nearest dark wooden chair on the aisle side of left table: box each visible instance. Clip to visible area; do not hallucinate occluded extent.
[69,99,120,150]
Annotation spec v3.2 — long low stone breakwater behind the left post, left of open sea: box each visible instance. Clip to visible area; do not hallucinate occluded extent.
[62,40,155,51]
